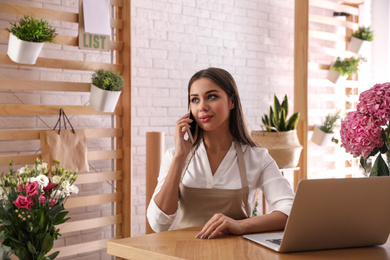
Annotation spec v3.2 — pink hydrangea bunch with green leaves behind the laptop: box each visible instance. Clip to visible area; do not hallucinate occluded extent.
[340,82,390,176]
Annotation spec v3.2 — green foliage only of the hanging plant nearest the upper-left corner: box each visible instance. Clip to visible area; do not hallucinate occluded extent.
[7,15,57,42]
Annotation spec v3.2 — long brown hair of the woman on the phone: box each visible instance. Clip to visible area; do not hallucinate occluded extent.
[188,67,256,147]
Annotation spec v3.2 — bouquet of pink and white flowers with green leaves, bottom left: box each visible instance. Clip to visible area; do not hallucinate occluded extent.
[0,159,79,260]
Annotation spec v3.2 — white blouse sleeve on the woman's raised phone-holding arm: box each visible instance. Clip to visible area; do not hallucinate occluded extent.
[146,148,176,232]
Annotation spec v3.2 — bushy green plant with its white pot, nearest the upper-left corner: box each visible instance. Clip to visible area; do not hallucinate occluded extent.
[7,15,57,64]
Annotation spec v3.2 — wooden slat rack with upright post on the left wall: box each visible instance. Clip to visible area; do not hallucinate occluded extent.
[0,0,131,259]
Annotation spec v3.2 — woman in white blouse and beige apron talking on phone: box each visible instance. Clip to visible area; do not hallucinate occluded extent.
[147,68,294,239]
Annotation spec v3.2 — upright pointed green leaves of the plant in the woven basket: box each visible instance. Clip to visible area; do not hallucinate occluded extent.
[261,95,300,132]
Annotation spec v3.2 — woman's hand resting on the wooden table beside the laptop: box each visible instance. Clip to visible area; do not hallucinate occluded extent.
[196,213,244,239]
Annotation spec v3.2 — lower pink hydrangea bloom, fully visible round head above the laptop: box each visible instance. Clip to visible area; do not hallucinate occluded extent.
[340,111,383,158]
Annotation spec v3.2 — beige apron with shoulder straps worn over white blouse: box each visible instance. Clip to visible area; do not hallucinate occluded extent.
[177,141,251,228]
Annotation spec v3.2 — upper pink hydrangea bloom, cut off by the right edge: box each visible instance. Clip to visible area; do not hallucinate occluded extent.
[357,82,390,125]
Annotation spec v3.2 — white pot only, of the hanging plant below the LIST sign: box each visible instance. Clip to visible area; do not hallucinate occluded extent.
[89,84,122,113]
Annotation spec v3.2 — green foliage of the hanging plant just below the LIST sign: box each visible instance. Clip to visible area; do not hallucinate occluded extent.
[92,69,124,91]
